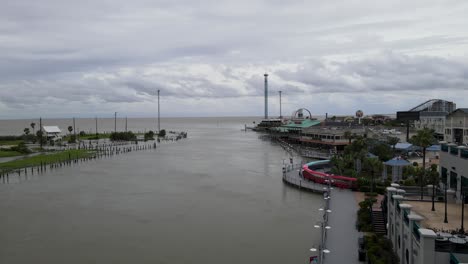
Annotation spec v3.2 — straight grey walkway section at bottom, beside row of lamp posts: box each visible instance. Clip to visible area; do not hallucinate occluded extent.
[324,188,361,264]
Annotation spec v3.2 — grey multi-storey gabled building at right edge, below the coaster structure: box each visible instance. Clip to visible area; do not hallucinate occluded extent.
[444,108,468,145]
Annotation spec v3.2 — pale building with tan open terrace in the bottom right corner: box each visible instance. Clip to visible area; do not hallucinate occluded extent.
[383,184,468,264]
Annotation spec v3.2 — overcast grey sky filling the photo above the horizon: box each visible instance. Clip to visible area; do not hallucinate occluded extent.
[0,0,468,119]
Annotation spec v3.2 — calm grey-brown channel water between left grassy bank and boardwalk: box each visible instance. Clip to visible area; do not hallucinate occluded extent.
[0,118,322,264]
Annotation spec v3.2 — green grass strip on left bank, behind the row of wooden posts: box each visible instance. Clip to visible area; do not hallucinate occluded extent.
[0,149,93,171]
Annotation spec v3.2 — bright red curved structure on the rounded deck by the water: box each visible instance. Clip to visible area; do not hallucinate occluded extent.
[302,160,357,190]
